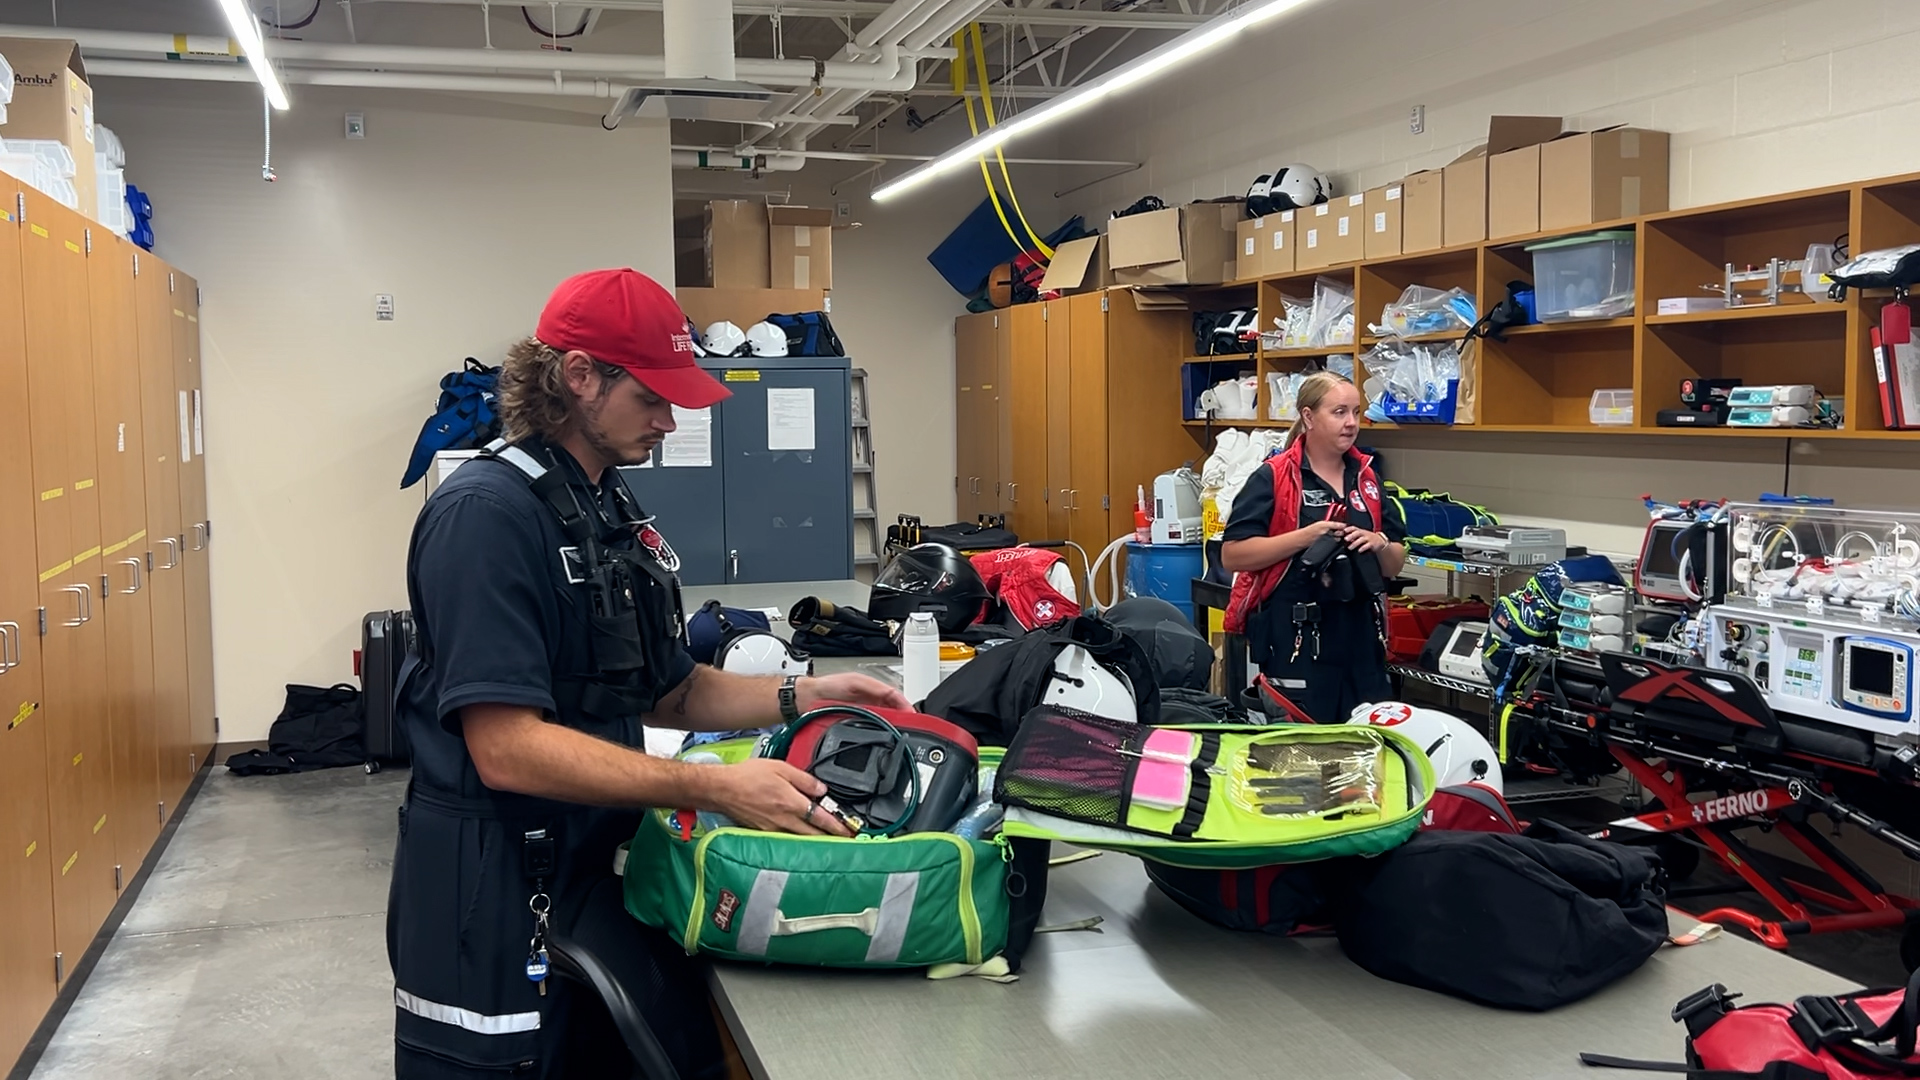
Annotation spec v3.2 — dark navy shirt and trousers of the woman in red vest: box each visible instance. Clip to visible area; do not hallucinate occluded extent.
[1225,449,1407,723]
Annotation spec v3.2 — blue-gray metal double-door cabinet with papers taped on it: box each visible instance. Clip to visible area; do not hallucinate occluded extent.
[624,357,852,584]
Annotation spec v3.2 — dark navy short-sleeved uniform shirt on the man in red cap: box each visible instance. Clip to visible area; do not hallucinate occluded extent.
[397,438,693,798]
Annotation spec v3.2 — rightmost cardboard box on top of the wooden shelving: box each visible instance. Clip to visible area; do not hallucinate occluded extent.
[1540,127,1668,231]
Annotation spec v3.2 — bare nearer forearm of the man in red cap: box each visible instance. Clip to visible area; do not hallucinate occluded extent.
[461,705,716,807]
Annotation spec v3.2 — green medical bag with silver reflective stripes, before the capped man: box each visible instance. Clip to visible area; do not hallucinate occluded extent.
[624,740,1008,967]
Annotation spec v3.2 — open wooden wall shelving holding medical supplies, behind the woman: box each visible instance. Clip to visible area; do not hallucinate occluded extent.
[1183,165,1920,442]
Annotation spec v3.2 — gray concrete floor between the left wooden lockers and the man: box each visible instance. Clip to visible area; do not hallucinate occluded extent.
[33,769,407,1080]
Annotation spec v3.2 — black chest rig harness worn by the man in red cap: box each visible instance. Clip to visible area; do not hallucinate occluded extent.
[480,440,685,723]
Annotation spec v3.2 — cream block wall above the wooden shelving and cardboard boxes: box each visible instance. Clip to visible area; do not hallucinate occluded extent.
[1060,0,1920,217]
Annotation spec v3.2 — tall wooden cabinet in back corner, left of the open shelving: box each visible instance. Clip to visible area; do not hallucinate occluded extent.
[956,292,1200,553]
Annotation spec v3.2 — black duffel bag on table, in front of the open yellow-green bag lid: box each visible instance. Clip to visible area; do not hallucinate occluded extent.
[1334,821,1667,1011]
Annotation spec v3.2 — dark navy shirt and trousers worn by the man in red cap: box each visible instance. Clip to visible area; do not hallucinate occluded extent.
[388,441,718,1080]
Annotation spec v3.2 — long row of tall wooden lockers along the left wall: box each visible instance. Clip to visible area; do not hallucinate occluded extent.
[0,193,213,1065]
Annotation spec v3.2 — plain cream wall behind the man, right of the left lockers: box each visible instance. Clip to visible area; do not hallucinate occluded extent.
[107,79,672,742]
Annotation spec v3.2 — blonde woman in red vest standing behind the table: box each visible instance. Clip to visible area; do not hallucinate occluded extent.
[1221,371,1407,724]
